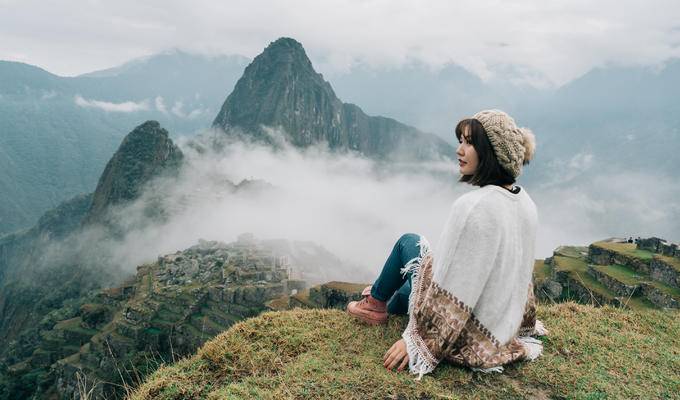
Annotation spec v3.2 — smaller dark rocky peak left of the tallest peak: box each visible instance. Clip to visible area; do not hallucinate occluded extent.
[86,121,183,224]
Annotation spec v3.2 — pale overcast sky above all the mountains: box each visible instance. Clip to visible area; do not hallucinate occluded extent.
[0,0,680,85]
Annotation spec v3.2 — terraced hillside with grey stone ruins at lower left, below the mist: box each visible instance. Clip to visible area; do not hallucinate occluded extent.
[13,234,308,398]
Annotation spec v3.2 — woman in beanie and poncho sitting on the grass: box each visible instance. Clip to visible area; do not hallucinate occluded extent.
[347,110,547,379]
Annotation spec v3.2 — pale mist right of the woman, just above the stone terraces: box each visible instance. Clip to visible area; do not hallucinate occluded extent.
[532,170,680,256]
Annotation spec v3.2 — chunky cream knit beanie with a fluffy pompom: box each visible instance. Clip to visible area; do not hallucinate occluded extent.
[472,110,536,178]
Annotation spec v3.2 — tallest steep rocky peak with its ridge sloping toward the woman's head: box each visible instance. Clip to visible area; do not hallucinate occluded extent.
[213,38,454,159]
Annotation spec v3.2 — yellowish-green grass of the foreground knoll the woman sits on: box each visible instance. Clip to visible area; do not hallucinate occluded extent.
[131,303,680,400]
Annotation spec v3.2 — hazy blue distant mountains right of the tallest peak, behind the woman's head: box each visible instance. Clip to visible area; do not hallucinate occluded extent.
[327,59,680,184]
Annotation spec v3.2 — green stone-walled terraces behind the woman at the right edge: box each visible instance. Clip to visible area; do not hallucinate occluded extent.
[534,237,680,309]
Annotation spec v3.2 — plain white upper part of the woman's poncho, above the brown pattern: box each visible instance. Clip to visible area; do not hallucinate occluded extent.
[434,185,538,344]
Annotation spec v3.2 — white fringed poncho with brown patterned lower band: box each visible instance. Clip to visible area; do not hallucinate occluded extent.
[402,185,543,379]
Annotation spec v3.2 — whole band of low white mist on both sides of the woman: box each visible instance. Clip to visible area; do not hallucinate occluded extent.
[41,131,680,282]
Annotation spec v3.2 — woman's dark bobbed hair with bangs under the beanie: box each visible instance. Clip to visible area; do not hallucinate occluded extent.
[456,118,515,186]
